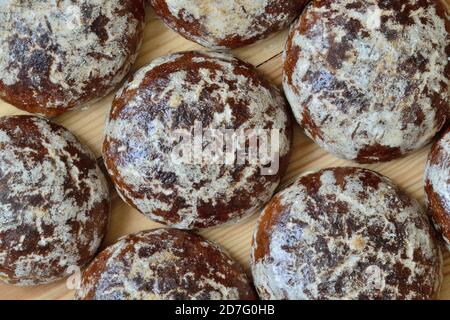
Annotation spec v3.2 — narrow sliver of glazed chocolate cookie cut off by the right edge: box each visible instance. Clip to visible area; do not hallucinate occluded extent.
[425,128,450,249]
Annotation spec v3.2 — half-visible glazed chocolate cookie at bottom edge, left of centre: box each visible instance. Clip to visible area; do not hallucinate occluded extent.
[75,229,256,300]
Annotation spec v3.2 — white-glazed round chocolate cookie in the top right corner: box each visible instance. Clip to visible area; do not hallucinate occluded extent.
[283,0,450,163]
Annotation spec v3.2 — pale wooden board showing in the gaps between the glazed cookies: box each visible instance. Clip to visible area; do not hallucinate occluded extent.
[0,5,450,299]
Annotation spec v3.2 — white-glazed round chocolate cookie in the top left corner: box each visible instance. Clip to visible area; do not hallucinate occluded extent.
[0,0,145,116]
